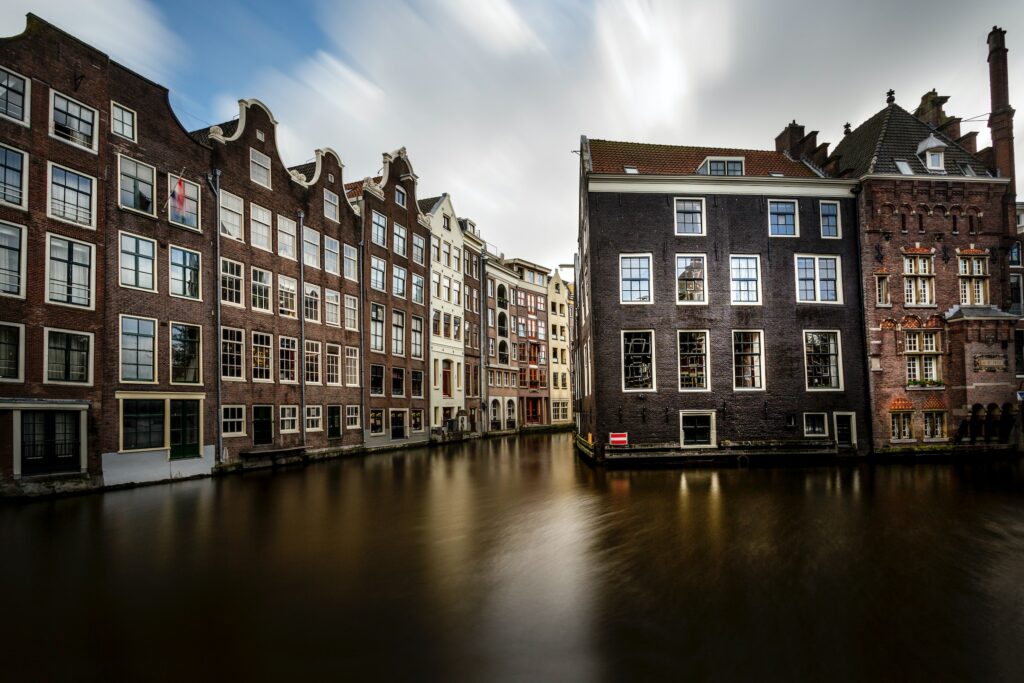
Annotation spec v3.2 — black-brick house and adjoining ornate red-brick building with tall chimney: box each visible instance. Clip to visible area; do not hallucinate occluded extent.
[575,28,1024,460]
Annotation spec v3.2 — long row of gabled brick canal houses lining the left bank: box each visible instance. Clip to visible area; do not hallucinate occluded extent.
[0,14,569,495]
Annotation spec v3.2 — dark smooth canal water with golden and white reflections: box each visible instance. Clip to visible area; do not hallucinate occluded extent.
[0,434,1024,681]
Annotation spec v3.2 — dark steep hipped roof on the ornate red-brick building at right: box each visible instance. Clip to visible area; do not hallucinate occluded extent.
[828,102,988,177]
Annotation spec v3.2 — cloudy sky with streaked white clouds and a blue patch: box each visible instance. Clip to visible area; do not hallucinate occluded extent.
[0,0,1024,267]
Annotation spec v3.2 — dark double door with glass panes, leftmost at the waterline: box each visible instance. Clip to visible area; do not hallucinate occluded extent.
[22,411,82,476]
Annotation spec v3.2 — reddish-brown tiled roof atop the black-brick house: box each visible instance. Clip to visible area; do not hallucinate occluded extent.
[589,140,818,178]
